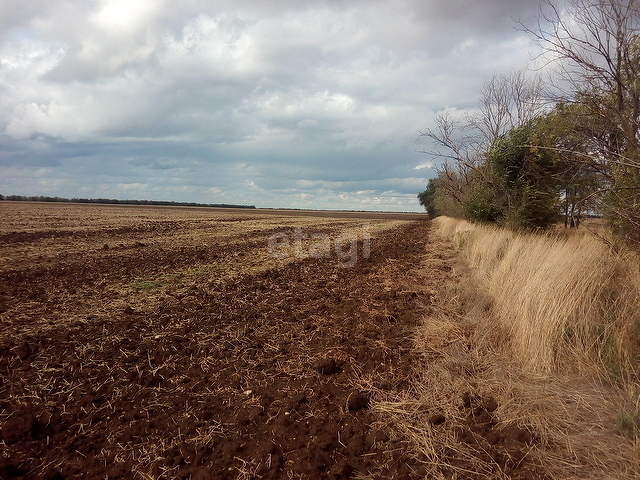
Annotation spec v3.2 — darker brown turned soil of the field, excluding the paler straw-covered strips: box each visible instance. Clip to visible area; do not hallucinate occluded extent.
[0,216,429,479]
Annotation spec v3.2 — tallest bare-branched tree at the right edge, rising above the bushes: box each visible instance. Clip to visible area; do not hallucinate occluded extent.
[523,0,640,240]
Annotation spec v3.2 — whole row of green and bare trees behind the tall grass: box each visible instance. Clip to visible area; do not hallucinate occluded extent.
[418,0,640,245]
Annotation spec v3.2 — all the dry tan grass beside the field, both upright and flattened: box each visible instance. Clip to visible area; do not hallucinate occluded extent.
[376,218,640,479]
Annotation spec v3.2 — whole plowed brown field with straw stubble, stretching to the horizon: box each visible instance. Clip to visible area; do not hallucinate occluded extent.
[0,202,437,479]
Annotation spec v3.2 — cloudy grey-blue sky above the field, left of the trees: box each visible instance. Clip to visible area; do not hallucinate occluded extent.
[0,0,538,211]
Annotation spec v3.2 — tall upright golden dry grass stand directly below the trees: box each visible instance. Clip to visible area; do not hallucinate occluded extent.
[435,217,640,382]
